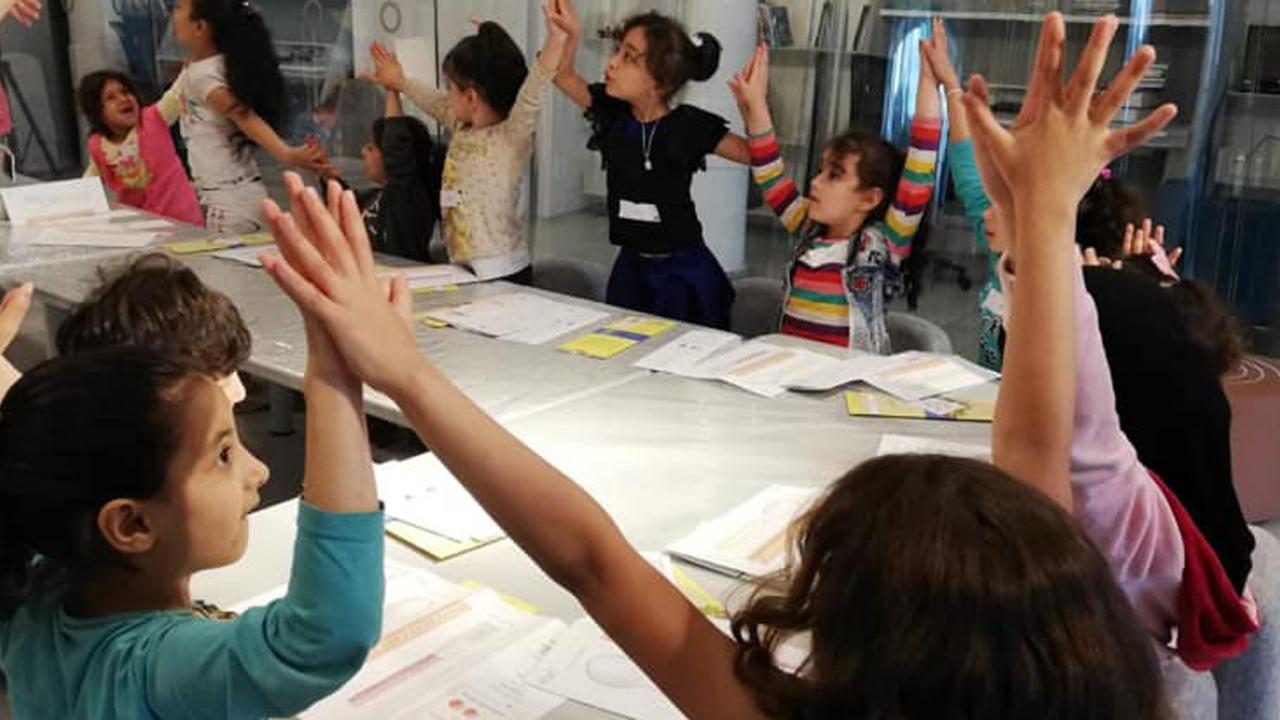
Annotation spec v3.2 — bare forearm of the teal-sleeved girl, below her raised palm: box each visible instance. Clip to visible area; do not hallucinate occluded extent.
[302,368,378,512]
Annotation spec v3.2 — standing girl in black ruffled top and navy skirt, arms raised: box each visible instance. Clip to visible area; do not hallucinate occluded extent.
[554,0,750,329]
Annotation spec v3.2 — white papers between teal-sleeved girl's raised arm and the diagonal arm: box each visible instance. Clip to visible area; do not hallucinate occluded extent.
[374,454,506,560]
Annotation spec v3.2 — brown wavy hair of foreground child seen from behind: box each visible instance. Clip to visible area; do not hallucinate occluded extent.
[732,455,1169,720]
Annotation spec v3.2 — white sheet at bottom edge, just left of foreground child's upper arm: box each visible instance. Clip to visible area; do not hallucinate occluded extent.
[529,618,685,720]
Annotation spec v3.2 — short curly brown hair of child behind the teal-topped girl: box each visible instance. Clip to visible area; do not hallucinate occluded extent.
[55,252,252,377]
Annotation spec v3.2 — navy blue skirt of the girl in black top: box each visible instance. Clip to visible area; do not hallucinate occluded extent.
[607,243,733,331]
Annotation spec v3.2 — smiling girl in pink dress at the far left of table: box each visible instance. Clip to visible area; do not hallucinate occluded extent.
[76,70,205,225]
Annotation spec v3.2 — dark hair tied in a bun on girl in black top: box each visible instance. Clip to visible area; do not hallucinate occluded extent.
[614,12,721,100]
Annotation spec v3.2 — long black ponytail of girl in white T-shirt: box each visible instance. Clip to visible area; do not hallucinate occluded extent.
[191,0,287,129]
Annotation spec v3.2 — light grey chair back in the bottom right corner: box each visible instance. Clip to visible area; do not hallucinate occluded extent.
[1213,527,1280,720]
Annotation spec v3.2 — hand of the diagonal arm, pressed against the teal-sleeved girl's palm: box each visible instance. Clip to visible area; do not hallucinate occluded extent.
[260,176,424,393]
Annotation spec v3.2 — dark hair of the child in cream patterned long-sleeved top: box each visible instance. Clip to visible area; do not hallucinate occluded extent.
[442,22,529,118]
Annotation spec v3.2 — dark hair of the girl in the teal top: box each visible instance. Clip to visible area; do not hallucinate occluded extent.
[0,346,200,616]
